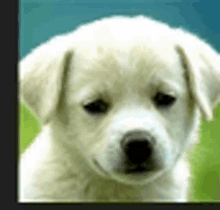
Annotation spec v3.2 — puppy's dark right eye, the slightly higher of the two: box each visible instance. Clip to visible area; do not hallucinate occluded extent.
[153,92,176,108]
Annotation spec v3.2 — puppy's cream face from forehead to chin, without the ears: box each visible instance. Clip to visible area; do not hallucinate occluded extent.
[66,43,197,184]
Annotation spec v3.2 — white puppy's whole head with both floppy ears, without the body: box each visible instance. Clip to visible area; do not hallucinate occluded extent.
[20,17,220,184]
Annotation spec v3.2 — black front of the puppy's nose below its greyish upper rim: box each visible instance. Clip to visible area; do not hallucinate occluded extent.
[124,139,152,164]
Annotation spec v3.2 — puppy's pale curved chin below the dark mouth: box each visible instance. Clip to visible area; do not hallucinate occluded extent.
[93,160,163,185]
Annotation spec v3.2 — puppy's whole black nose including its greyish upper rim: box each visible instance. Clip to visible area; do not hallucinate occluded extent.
[122,131,154,165]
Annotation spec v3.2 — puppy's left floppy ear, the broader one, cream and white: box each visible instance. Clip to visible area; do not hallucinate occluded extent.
[18,35,73,124]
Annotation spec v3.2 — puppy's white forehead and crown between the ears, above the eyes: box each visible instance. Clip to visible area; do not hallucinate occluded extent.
[70,16,184,88]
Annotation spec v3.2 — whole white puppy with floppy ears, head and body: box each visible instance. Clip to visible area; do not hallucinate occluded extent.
[19,16,220,202]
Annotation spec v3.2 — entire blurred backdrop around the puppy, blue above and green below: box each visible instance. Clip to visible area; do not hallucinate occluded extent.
[19,0,220,201]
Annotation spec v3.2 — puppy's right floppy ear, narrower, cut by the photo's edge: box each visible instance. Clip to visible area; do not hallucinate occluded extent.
[176,30,220,121]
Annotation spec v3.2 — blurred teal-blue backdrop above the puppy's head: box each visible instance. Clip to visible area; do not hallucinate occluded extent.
[20,0,220,56]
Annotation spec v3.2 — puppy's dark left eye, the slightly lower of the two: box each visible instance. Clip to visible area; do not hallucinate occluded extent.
[84,99,108,114]
